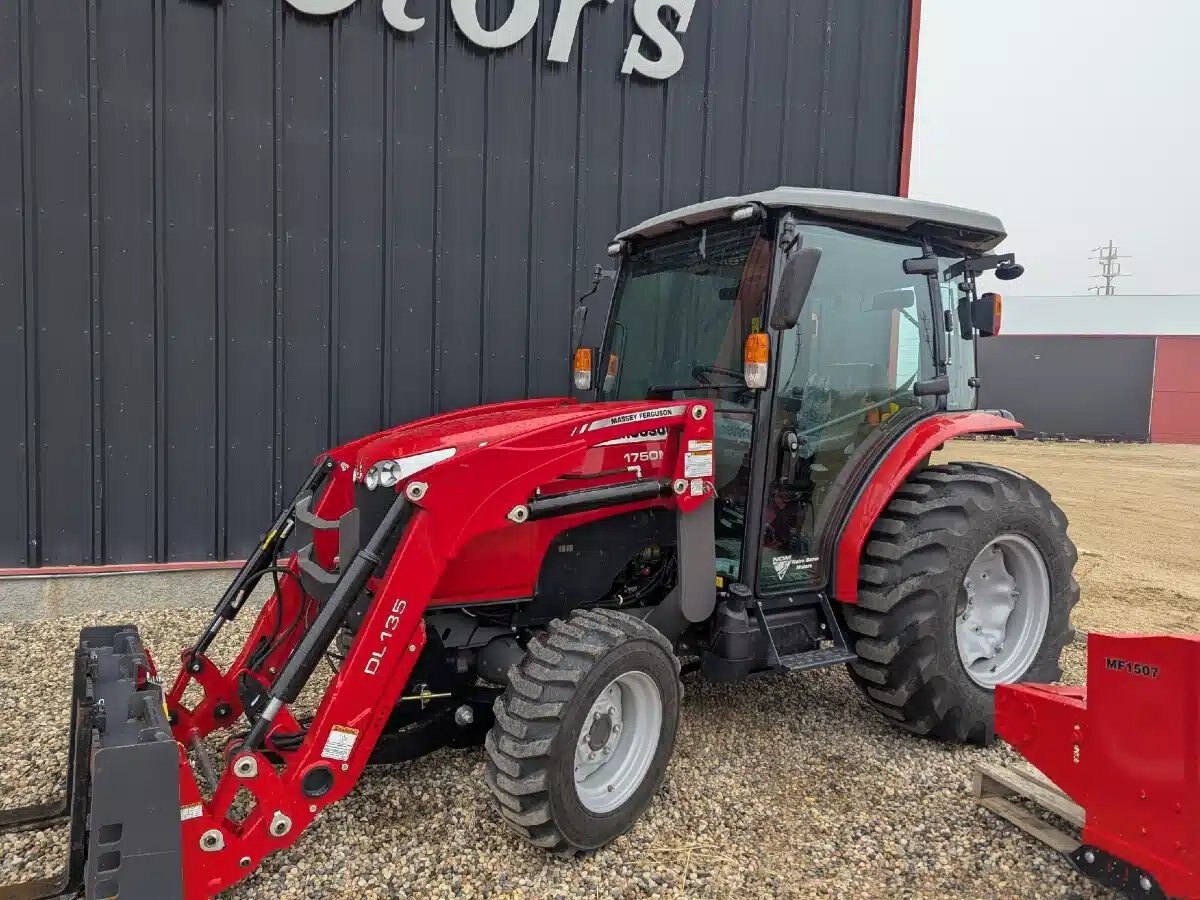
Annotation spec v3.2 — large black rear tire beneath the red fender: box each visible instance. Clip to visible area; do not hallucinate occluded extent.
[842,463,1079,743]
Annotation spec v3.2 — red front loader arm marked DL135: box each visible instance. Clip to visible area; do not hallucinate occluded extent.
[0,401,715,900]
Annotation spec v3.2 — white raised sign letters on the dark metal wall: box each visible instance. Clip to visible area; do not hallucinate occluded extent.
[288,0,696,79]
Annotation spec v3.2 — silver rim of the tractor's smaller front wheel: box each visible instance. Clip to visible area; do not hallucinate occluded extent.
[575,672,662,814]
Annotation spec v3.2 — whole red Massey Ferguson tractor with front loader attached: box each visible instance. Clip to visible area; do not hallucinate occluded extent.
[5,188,1079,900]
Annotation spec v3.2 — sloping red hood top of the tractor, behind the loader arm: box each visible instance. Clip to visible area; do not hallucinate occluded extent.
[331,397,686,481]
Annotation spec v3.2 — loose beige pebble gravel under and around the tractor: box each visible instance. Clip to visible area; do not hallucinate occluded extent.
[0,610,1103,900]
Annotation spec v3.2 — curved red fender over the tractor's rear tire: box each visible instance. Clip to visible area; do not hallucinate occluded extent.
[833,413,1021,604]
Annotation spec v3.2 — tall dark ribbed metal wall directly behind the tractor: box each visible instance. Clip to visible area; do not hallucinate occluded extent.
[0,0,911,566]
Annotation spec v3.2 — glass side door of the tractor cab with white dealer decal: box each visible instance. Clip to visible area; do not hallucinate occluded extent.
[757,224,937,594]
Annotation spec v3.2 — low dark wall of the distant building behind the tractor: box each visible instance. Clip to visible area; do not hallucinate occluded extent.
[979,335,1157,440]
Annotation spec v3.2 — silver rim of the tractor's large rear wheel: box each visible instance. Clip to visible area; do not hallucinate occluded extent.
[954,534,1050,688]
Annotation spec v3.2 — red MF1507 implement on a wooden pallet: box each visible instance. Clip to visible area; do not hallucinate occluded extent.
[996,635,1200,896]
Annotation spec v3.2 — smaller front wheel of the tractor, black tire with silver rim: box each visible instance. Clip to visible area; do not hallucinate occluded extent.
[485,610,683,857]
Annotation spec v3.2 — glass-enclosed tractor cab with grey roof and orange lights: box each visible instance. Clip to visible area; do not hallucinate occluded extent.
[575,187,1021,596]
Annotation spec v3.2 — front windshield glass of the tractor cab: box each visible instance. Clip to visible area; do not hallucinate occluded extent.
[600,222,772,400]
